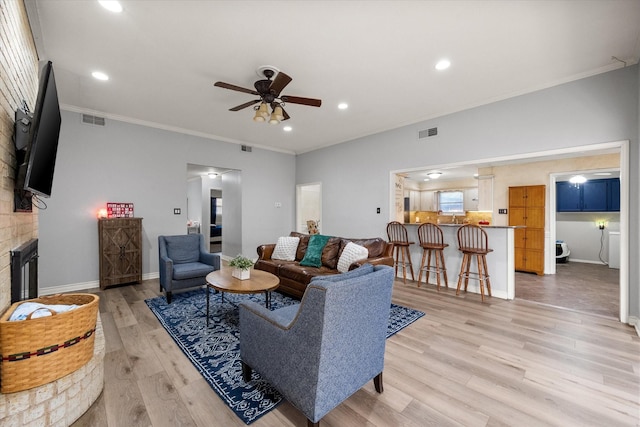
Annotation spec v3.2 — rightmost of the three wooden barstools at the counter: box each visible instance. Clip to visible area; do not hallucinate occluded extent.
[456,224,493,302]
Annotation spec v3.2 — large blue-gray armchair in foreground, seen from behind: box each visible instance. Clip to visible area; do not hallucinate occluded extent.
[240,264,394,426]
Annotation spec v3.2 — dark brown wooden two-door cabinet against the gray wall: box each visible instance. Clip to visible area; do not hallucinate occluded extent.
[98,218,142,289]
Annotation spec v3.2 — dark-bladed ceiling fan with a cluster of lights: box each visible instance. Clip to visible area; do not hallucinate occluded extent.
[214,66,322,124]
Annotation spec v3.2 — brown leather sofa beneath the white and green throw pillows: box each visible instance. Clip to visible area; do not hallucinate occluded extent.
[253,231,393,298]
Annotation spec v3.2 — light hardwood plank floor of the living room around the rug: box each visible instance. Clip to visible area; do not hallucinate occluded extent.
[74,280,640,427]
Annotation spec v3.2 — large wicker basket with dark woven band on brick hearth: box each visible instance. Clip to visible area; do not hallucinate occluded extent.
[0,294,99,393]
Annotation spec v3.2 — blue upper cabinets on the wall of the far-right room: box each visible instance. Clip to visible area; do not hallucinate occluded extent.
[556,178,620,212]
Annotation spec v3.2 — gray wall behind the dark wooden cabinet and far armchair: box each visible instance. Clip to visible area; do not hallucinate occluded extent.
[39,111,295,294]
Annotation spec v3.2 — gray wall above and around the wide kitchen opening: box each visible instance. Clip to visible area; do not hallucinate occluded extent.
[296,65,640,316]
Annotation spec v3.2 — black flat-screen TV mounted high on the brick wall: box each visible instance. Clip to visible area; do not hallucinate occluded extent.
[17,61,62,197]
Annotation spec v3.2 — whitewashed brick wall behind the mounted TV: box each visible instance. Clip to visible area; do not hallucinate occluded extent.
[0,0,38,313]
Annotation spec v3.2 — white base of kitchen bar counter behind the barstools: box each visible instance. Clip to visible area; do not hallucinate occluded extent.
[398,223,518,301]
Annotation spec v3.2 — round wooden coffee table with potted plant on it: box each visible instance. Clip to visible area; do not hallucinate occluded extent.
[202,268,280,326]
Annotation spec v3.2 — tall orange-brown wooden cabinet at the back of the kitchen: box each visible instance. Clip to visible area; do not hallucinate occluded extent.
[509,185,546,275]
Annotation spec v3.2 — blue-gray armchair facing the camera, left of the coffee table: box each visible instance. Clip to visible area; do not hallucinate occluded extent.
[158,234,220,304]
